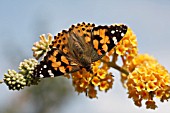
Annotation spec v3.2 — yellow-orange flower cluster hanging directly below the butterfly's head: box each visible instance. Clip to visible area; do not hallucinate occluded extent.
[69,61,114,98]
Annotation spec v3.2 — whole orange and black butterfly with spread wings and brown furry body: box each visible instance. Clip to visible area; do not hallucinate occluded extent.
[33,22,128,78]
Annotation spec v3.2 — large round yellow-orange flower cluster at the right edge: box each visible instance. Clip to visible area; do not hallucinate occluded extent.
[126,54,170,109]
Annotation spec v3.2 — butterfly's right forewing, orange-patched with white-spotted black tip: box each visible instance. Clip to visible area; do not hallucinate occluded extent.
[92,24,127,62]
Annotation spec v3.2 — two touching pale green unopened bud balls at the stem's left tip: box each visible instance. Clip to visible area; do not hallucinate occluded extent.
[4,59,40,90]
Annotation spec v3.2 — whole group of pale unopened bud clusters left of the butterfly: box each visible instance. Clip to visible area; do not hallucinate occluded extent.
[3,34,53,90]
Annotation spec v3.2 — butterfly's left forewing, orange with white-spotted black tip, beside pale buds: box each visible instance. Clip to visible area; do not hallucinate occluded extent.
[34,48,80,78]
